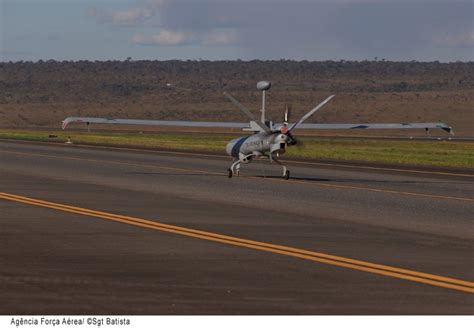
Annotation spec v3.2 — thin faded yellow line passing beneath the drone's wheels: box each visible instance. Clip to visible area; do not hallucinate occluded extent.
[0,150,474,202]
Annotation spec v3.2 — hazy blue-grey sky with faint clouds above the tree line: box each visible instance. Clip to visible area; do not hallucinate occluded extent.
[0,0,474,62]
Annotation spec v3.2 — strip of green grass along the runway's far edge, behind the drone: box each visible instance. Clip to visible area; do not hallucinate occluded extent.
[0,129,474,168]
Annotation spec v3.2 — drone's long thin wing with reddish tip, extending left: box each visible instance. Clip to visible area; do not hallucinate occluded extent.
[62,117,249,130]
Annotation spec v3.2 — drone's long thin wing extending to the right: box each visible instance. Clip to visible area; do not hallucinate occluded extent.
[298,123,454,134]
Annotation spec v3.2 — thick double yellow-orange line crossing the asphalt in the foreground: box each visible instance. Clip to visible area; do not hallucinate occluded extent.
[0,192,474,293]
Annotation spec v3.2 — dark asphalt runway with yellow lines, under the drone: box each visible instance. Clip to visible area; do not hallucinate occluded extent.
[0,141,474,314]
